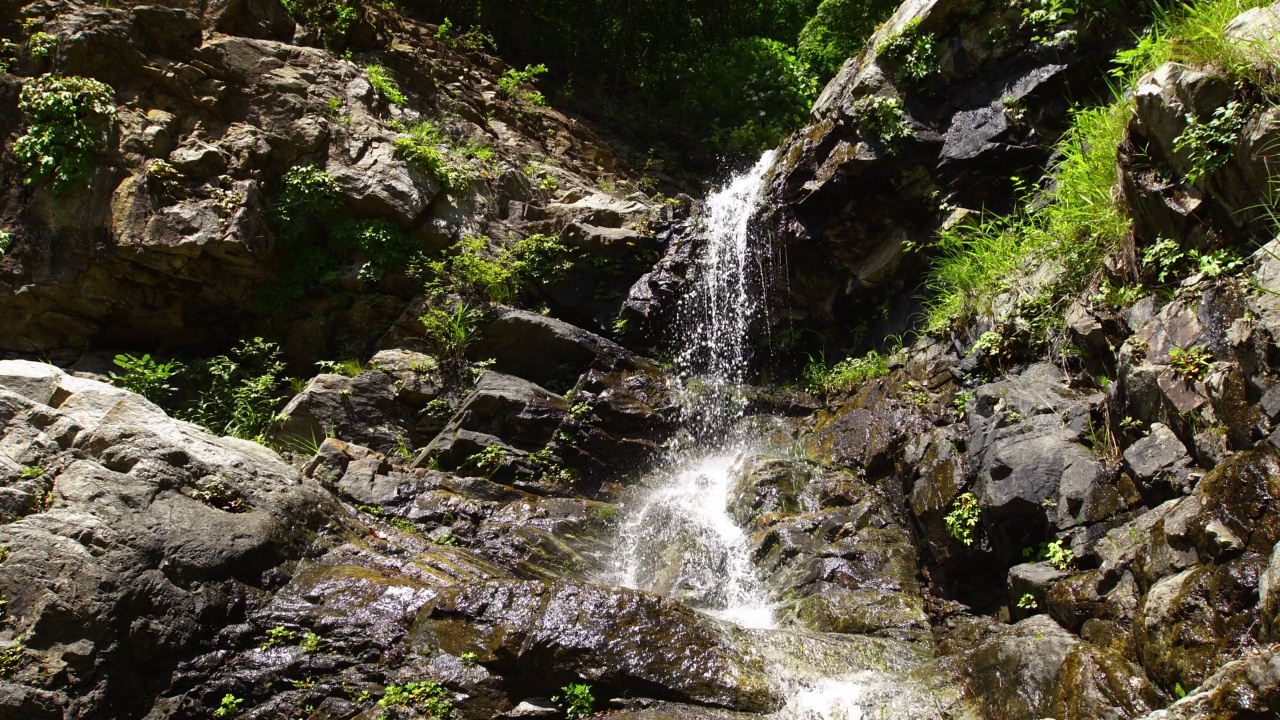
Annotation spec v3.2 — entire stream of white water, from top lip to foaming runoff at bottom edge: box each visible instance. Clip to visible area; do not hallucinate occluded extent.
[613,151,962,720]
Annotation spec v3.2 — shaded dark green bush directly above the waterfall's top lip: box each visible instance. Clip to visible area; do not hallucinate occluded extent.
[680,37,818,155]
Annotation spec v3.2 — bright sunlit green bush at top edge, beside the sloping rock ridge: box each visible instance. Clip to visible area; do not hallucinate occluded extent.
[796,0,897,77]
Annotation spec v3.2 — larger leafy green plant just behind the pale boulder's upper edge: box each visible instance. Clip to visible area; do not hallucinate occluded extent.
[179,337,284,442]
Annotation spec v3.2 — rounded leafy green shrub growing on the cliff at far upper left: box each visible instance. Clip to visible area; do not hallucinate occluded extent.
[13,74,115,192]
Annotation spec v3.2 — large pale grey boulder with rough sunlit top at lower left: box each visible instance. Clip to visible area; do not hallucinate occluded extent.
[0,361,339,717]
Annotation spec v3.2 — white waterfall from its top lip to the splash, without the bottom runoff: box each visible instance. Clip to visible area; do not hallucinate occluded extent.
[618,151,773,628]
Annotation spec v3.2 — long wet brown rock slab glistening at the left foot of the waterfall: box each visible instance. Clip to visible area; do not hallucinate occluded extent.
[413,573,781,712]
